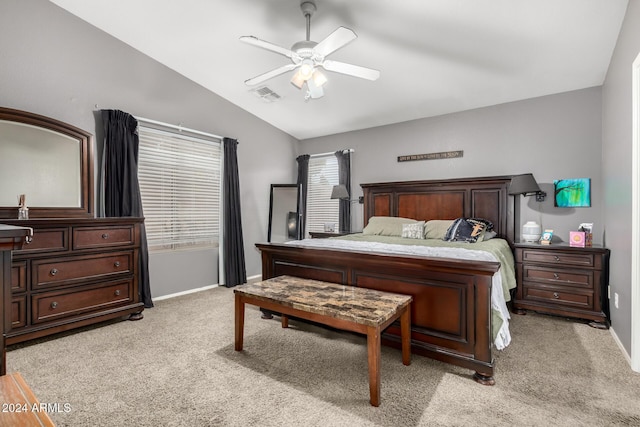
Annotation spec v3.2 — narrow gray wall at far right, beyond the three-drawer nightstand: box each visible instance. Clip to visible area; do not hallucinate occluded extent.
[602,1,640,357]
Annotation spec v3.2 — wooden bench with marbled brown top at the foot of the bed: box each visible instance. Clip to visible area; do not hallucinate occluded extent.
[234,276,412,406]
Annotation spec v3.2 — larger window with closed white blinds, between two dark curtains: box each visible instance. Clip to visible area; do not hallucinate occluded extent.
[138,125,222,251]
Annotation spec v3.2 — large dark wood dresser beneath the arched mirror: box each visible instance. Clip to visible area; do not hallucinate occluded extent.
[2,218,143,345]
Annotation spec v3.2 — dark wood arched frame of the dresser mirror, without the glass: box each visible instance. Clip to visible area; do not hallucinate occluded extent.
[0,107,94,219]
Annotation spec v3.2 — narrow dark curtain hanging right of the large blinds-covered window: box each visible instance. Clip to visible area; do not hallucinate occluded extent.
[223,138,247,288]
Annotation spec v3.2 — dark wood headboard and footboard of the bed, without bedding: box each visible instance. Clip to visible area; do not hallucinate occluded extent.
[256,176,515,385]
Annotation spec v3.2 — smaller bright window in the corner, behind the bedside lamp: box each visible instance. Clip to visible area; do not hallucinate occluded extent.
[306,153,340,233]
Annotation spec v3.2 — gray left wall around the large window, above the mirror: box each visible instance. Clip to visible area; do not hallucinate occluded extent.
[0,0,297,296]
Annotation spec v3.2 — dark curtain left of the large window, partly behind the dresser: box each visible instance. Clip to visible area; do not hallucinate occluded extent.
[100,110,153,308]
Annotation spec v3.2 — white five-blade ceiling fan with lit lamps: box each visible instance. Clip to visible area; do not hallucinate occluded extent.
[240,0,380,99]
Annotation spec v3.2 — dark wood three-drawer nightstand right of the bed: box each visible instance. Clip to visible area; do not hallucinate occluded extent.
[513,243,610,329]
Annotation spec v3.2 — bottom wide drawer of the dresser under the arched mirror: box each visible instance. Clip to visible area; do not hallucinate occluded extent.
[31,279,134,324]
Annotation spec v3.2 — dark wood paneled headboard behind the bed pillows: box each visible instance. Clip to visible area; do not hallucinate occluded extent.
[360,176,515,243]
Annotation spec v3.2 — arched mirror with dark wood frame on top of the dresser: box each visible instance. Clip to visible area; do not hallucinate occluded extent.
[0,108,93,219]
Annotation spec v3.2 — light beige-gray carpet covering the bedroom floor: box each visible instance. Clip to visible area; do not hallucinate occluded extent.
[7,288,640,427]
